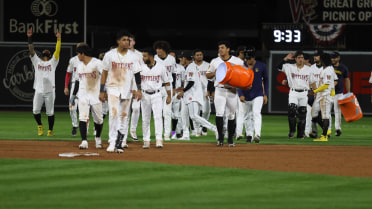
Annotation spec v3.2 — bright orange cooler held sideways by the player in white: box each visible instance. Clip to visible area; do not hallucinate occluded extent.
[216,62,254,88]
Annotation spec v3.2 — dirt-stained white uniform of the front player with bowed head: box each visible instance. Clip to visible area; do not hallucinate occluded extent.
[76,57,103,124]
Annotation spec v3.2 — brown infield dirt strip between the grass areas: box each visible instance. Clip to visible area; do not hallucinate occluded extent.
[0,140,372,177]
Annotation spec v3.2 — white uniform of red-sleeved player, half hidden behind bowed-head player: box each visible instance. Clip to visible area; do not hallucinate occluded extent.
[66,55,81,127]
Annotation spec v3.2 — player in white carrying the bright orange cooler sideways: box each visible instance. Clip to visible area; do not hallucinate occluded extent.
[206,41,244,147]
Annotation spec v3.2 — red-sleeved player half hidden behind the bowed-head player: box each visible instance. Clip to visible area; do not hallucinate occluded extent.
[64,43,86,136]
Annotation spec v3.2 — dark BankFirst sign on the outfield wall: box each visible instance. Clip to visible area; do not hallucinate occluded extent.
[4,0,86,43]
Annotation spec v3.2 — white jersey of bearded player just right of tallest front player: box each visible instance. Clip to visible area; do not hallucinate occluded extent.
[141,62,170,92]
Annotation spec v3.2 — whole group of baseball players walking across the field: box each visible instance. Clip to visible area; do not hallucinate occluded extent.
[27,28,350,153]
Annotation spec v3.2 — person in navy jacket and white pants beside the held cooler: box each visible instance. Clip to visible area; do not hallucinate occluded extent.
[236,47,269,143]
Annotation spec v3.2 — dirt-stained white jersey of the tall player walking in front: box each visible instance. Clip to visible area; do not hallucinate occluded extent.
[103,48,141,99]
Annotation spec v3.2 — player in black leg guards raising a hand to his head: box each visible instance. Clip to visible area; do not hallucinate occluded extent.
[277,50,315,139]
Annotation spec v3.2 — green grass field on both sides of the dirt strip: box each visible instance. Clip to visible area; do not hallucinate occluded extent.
[0,112,372,209]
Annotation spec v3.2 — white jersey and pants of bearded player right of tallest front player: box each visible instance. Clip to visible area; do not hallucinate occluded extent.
[141,62,170,141]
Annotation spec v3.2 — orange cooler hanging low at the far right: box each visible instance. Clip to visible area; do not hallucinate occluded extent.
[338,93,363,122]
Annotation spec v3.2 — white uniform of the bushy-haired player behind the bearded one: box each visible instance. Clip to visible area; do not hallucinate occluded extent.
[154,54,176,139]
